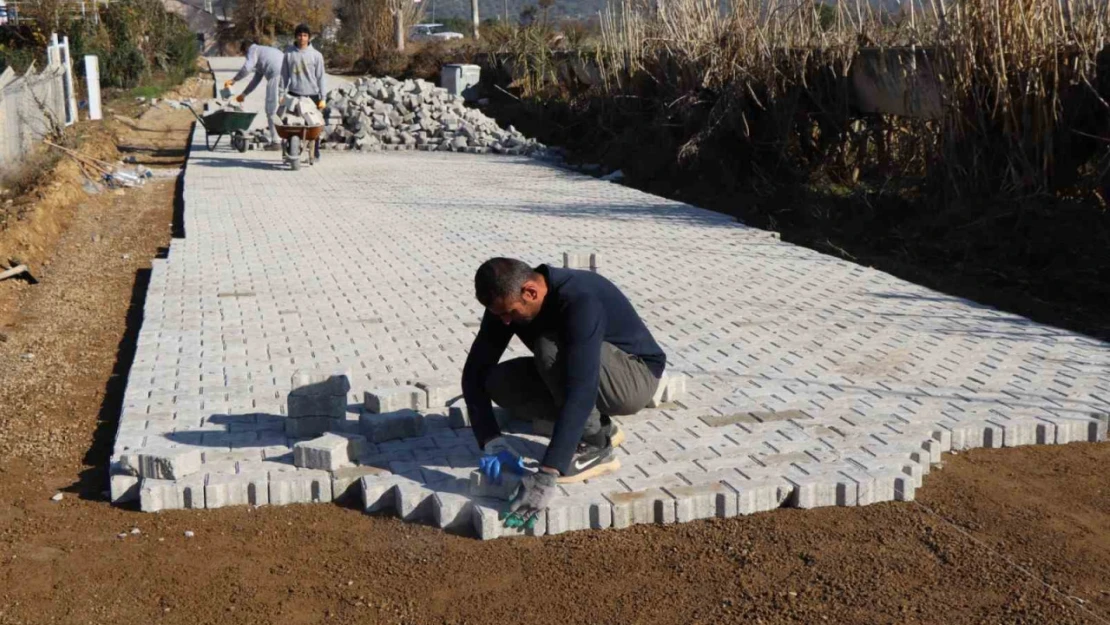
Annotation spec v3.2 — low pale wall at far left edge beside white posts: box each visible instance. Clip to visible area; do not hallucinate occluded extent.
[0,67,65,169]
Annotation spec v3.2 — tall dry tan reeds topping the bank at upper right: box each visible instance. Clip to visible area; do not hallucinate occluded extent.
[596,0,1110,201]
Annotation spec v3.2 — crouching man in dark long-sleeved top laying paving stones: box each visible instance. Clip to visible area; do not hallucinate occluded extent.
[463,258,667,526]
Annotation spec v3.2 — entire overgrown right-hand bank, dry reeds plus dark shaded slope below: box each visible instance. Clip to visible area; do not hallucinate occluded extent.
[432,0,1110,335]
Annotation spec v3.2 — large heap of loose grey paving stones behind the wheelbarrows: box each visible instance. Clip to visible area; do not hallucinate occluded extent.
[326,77,547,157]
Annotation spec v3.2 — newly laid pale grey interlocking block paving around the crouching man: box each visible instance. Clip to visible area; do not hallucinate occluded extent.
[115,57,1110,537]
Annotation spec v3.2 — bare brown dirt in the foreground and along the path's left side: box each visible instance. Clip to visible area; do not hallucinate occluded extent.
[0,68,1110,625]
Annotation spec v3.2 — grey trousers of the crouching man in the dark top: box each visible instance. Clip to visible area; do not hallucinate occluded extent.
[486,336,659,441]
